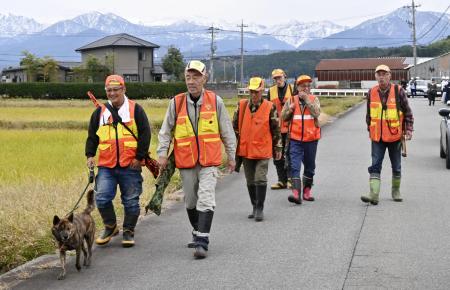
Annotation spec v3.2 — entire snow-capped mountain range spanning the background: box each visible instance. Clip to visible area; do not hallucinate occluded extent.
[0,8,450,67]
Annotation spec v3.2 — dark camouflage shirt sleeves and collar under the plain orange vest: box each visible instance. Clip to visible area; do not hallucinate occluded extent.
[233,98,283,152]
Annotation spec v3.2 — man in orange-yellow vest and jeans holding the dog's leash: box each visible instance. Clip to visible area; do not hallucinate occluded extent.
[85,75,151,247]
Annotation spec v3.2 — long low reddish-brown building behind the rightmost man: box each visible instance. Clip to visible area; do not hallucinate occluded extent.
[315,57,408,88]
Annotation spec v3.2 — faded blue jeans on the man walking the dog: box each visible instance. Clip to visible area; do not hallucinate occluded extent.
[95,167,143,215]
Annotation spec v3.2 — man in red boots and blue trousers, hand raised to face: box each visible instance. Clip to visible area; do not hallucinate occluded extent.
[282,75,320,204]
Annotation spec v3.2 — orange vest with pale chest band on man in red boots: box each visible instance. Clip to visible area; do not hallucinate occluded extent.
[290,95,320,142]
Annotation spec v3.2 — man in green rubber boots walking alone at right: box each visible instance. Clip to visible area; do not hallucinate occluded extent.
[361,64,414,205]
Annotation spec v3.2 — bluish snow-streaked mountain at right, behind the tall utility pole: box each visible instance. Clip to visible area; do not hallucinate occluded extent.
[300,8,450,49]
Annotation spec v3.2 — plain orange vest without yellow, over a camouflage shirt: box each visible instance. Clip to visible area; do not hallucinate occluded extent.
[238,100,273,159]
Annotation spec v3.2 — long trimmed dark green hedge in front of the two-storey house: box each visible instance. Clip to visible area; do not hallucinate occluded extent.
[0,83,186,99]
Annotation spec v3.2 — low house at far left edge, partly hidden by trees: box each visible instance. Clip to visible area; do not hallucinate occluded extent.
[1,61,81,83]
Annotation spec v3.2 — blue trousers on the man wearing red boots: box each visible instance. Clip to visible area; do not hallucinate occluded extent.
[289,140,319,178]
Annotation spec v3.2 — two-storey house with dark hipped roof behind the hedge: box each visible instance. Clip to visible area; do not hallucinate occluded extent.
[75,33,165,82]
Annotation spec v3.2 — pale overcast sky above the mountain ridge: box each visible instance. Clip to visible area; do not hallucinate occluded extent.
[0,0,450,26]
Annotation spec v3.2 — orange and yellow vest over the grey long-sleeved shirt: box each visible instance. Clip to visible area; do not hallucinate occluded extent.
[174,90,222,168]
